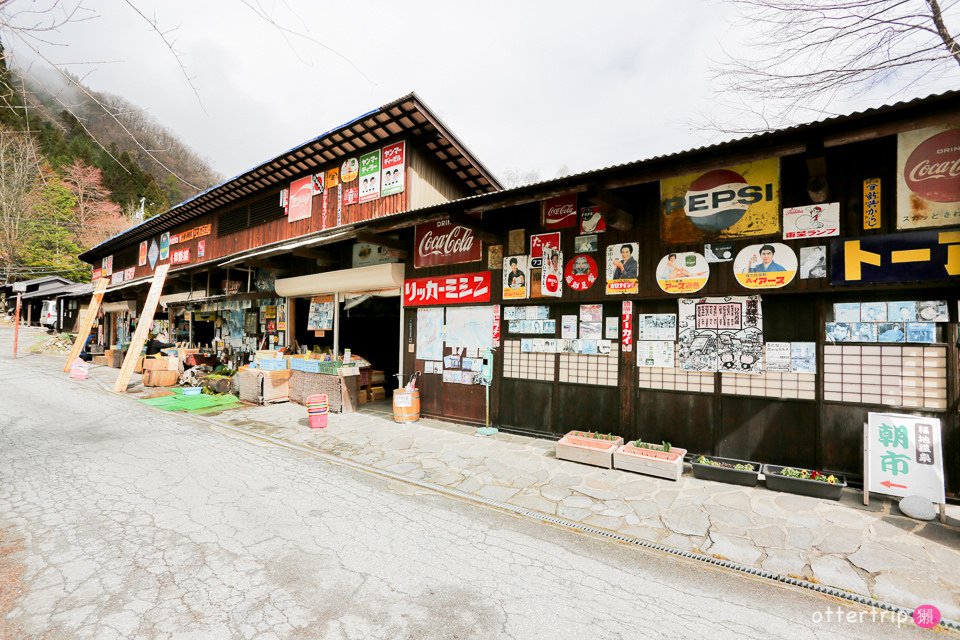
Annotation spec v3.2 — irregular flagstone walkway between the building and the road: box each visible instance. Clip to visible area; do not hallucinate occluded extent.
[86,369,960,620]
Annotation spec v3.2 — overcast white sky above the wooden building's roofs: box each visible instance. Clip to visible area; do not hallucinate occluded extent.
[10,0,947,188]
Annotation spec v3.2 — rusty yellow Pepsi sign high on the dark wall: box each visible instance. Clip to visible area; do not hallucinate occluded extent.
[660,158,780,244]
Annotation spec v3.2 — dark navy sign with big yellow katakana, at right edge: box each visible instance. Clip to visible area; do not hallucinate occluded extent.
[830,229,960,284]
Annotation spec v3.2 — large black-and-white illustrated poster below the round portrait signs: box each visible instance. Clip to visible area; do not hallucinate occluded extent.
[677,296,763,373]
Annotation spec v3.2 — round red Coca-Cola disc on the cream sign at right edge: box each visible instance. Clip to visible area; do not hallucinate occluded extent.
[903,129,960,202]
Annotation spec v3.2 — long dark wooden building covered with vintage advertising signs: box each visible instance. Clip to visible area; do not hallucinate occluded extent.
[82,92,960,497]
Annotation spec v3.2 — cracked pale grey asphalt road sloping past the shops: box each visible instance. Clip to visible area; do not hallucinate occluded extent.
[0,328,929,640]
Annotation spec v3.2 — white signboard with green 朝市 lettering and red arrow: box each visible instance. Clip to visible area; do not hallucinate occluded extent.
[863,412,945,504]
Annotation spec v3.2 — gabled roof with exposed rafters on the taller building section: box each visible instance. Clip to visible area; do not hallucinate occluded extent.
[80,93,503,261]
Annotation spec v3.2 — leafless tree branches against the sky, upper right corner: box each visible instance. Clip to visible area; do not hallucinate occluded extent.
[715,0,960,133]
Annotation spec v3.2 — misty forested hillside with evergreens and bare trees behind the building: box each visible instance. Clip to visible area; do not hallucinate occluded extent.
[0,38,220,282]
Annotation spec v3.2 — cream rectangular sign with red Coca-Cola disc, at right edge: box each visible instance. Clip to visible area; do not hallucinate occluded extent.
[897,124,960,229]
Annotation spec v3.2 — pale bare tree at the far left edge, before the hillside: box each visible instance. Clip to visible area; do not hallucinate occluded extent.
[0,128,40,276]
